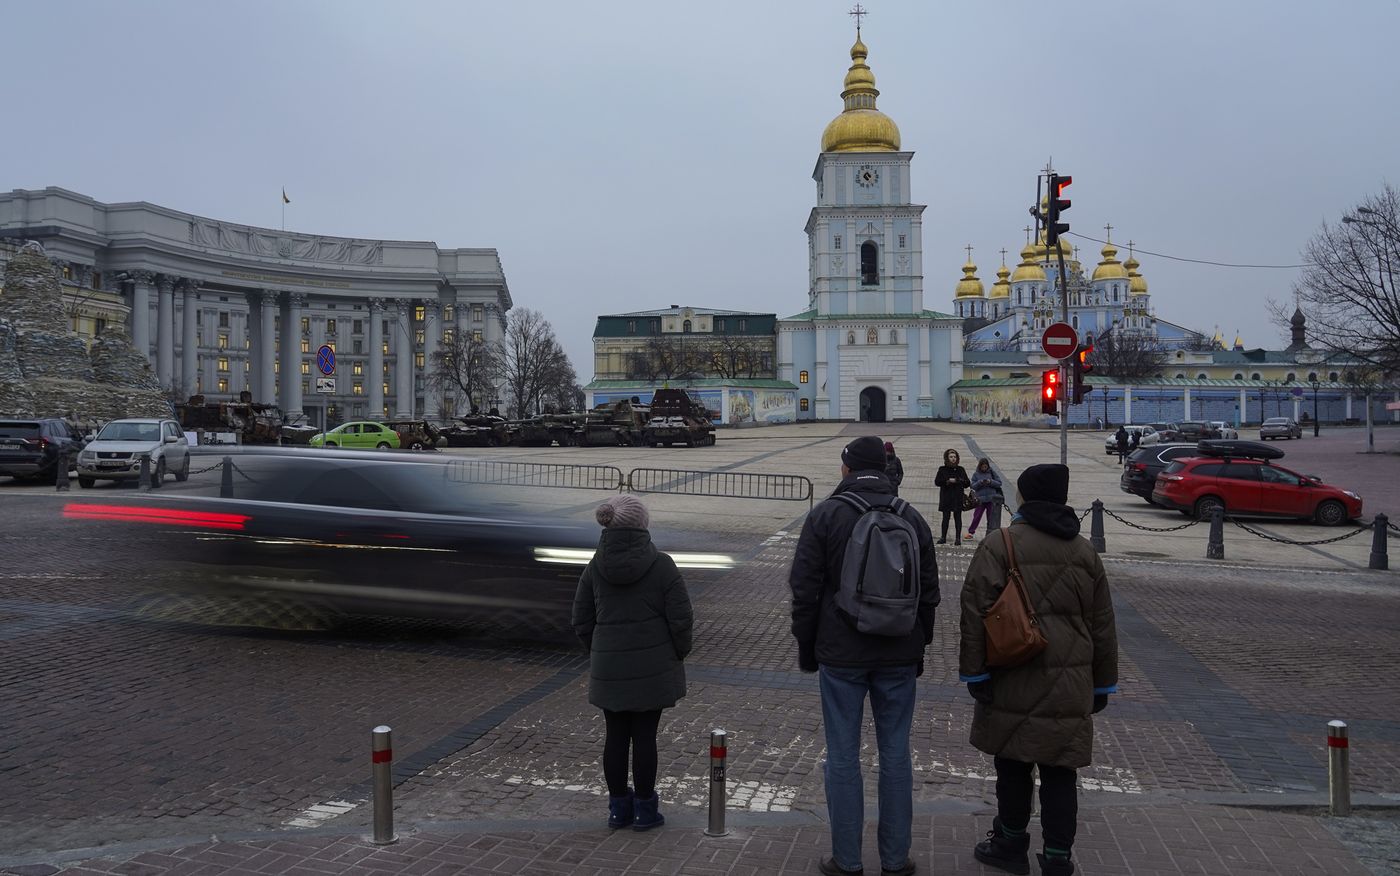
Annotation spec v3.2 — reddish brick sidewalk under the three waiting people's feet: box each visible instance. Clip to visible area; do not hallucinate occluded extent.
[10,799,1400,876]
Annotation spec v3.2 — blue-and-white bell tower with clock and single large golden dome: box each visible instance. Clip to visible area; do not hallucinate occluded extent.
[777,28,963,423]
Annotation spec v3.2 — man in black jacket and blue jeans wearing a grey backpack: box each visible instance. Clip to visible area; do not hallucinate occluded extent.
[788,437,938,876]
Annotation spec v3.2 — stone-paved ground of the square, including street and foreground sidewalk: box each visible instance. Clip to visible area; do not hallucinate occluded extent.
[0,423,1400,875]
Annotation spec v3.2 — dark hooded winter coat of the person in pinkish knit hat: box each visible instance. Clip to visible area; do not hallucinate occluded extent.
[574,528,694,712]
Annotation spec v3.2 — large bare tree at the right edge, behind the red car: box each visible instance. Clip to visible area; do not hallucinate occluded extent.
[1270,185,1400,378]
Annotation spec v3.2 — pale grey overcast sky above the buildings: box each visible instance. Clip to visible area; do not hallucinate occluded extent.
[0,0,1400,369]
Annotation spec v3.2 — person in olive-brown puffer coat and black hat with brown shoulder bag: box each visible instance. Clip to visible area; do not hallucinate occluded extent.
[958,465,1119,876]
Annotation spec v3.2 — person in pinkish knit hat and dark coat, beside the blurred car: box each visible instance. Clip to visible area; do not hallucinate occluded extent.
[574,493,694,830]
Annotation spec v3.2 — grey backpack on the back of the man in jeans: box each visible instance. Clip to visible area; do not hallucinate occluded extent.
[832,493,920,635]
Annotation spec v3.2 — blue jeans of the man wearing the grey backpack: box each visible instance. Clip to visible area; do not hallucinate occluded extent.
[820,666,916,870]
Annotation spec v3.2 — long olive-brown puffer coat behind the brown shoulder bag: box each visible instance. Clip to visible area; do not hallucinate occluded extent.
[958,502,1119,768]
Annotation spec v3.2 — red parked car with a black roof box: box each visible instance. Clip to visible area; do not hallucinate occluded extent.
[1152,441,1361,526]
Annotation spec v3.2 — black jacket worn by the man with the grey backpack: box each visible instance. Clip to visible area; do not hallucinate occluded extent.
[788,470,939,669]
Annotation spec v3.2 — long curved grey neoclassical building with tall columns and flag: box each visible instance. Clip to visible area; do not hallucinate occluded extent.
[0,186,511,424]
